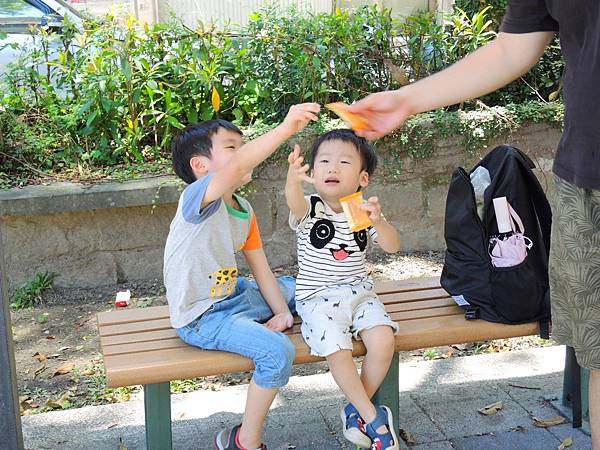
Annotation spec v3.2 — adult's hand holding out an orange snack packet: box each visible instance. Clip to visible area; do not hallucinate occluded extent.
[349,91,411,140]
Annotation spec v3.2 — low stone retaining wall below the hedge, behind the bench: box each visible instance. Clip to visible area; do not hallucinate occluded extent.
[0,124,560,289]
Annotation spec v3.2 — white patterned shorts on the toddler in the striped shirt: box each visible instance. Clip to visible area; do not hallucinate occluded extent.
[296,284,398,356]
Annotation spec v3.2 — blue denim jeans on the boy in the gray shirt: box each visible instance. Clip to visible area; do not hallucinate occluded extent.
[177,277,296,389]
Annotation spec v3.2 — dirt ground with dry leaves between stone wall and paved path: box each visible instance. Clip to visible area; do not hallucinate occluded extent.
[11,252,548,414]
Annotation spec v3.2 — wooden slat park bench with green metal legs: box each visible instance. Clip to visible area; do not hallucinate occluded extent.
[98,278,539,450]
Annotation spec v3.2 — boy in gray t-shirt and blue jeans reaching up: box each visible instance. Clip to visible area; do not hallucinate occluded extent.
[164,103,320,450]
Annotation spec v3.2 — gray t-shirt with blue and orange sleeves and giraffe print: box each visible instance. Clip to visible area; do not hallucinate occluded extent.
[163,175,262,328]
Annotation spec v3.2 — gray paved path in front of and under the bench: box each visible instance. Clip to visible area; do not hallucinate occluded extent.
[23,347,591,450]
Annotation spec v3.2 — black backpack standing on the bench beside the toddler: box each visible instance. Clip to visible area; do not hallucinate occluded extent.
[441,146,552,338]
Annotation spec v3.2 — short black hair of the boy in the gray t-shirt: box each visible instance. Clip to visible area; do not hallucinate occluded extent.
[171,119,244,184]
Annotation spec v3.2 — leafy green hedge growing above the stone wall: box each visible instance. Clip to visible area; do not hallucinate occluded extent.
[0,7,562,187]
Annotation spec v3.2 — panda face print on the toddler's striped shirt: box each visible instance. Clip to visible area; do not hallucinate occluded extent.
[309,197,367,261]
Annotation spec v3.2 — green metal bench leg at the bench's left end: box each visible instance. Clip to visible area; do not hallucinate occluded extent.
[144,382,173,450]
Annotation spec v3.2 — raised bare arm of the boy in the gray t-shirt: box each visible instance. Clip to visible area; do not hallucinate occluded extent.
[202,103,321,204]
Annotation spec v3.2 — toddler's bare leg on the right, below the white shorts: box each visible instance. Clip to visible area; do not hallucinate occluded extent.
[360,325,395,398]
